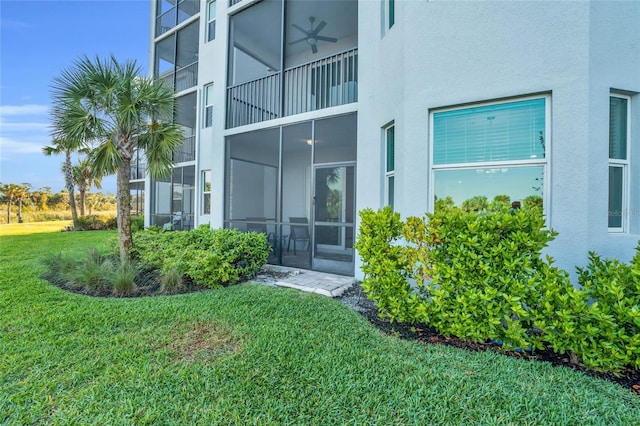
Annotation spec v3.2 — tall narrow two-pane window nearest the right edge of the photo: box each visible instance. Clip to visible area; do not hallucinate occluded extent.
[609,95,630,232]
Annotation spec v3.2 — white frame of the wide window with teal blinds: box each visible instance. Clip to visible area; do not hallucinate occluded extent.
[428,93,552,216]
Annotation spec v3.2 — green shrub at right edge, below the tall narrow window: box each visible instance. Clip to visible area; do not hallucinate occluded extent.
[571,244,640,371]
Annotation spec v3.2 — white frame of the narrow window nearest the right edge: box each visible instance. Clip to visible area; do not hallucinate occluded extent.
[607,92,631,234]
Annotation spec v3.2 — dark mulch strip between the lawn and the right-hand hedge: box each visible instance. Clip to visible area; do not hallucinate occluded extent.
[338,284,640,396]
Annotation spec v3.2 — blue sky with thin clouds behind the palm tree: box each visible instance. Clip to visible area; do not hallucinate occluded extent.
[0,0,151,192]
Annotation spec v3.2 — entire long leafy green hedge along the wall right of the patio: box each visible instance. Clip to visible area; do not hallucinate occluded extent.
[356,207,640,372]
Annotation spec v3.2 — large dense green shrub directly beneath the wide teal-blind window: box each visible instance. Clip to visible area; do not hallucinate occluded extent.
[424,208,573,348]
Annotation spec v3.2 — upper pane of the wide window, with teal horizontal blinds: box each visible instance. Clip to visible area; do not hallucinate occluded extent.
[433,98,545,164]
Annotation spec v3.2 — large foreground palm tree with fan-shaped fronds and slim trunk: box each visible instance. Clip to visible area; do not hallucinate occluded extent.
[52,56,184,260]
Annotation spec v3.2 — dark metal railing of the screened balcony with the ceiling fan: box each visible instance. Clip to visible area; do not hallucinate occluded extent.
[227,48,358,128]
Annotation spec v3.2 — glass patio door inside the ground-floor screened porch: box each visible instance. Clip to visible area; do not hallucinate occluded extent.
[312,163,355,275]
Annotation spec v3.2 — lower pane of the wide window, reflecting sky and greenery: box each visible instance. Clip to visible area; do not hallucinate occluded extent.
[435,166,544,211]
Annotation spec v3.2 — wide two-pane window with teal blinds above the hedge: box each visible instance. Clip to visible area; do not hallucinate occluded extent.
[431,96,549,212]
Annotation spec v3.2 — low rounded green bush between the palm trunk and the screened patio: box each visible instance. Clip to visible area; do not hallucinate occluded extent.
[134,225,271,288]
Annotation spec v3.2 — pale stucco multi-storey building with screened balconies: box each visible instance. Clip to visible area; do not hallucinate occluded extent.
[131,0,640,277]
